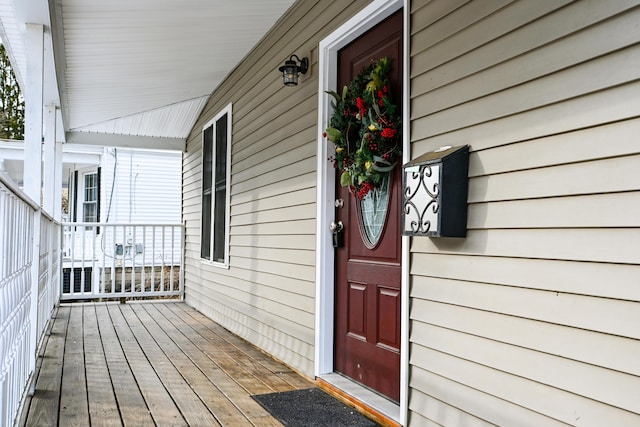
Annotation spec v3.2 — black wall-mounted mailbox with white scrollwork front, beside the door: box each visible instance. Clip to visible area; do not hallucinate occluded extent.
[402,145,469,237]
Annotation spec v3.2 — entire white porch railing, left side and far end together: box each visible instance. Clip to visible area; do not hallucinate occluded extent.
[0,173,184,426]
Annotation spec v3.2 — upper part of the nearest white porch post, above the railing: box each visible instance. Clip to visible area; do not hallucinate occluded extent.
[24,24,44,204]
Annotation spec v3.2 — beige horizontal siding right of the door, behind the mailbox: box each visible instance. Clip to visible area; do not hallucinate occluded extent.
[409,0,640,426]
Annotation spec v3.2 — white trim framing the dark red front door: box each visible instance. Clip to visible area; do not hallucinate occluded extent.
[315,0,410,424]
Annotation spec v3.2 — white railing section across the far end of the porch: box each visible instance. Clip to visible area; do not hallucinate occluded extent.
[61,222,184,300]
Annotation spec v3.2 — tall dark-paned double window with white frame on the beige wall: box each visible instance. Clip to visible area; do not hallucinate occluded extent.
[200,104,231,266]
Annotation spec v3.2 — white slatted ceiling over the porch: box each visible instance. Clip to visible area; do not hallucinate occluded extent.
[0,0,294,148]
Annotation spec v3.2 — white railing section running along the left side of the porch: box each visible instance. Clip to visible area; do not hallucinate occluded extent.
[0,174,60,426]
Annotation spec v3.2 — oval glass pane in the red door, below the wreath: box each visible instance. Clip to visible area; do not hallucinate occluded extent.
[358,174,391,249]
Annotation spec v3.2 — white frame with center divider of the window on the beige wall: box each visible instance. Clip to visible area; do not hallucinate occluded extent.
[200,103,233,268]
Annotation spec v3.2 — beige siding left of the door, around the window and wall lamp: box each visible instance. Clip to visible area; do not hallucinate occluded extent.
[183,0,368,376]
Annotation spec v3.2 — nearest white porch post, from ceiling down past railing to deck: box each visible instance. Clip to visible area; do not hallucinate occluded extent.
[23,24,44,374]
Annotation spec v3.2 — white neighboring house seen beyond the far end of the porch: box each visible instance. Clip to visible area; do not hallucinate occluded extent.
[0,141,182,292]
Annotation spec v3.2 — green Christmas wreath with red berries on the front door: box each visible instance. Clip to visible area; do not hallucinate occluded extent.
[323,58,402,199]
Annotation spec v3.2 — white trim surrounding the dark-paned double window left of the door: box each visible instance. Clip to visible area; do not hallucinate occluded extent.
[200,103,233,269]
